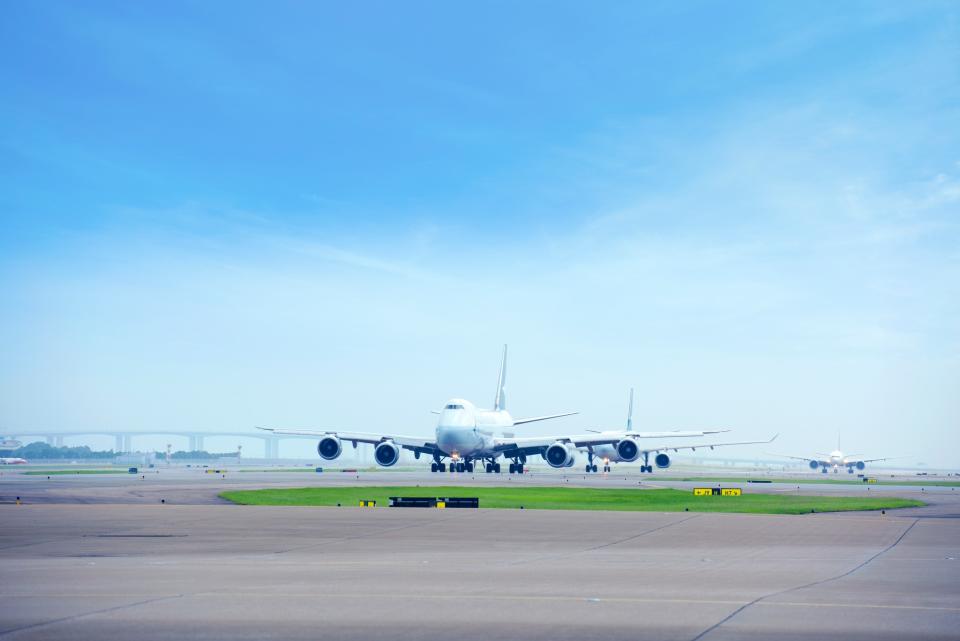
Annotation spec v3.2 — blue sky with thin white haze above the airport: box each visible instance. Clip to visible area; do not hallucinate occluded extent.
[0,1,960,468]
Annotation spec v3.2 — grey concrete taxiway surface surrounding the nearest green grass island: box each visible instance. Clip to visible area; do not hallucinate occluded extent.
[0,471,960,640]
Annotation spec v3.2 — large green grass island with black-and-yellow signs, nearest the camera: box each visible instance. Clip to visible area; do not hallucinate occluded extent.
[220,486,925,514]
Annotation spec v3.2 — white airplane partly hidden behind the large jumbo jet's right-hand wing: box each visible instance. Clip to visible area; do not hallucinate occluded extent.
[584,388,777,474]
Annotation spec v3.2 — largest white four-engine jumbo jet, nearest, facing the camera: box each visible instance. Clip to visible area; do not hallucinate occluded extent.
[258,345,776,474]
